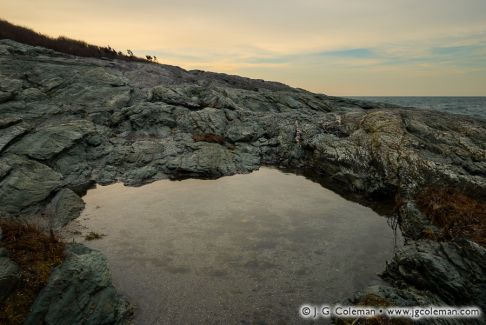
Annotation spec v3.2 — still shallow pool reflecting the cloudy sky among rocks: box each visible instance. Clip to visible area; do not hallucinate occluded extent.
[63,168,394,324]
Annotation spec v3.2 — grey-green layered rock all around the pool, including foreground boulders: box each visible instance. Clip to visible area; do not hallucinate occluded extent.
[0,40,486,324]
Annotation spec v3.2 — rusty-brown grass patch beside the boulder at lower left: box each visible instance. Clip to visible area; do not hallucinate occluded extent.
[0,220,64,324]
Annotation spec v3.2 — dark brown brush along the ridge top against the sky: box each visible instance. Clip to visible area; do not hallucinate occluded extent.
[0,19,151,62]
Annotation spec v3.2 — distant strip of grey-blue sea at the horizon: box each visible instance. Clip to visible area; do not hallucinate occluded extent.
[348,96,486,119]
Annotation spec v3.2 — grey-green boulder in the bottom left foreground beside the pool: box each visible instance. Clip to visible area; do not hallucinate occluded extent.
[25,244,132,325]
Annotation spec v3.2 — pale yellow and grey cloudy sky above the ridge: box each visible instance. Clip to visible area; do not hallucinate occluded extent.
[0,0,486,96]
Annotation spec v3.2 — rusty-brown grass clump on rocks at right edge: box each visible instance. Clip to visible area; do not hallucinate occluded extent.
[416,188,486,246]
